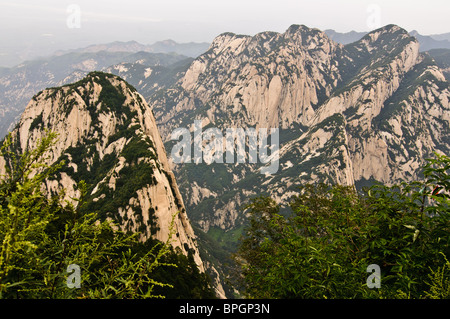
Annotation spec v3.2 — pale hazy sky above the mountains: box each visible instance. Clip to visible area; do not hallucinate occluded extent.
[0,0,450,65]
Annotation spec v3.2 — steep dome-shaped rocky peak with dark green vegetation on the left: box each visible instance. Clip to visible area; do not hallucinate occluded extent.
[0,72,203,271]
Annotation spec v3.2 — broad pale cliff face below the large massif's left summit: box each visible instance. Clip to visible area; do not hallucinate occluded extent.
[152,26,342,138]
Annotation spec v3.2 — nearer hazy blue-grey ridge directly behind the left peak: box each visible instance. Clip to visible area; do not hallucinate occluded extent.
[0,47,189,138]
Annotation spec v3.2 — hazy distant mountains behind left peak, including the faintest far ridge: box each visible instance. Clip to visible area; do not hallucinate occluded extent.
[0,40,209,138]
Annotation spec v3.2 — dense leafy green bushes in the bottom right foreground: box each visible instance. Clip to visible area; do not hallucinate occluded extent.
[236,155,450,298]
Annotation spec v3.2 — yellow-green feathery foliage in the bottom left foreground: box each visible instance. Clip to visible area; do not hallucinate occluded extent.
[0,133,214,298]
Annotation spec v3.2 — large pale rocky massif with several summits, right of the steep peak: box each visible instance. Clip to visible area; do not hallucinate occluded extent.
[142,25,450,298]
